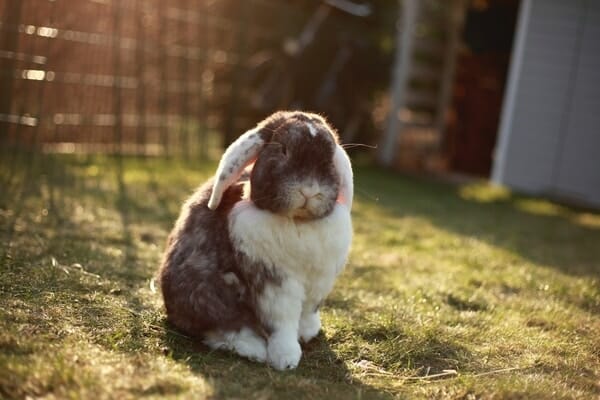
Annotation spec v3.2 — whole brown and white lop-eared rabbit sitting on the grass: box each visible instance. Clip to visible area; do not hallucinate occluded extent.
[159,111,353,370]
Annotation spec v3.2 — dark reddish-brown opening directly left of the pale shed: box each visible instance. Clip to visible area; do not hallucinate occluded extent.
[444,0,520,176]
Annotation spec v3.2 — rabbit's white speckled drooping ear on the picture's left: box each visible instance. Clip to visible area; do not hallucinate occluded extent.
[208,127,265,210]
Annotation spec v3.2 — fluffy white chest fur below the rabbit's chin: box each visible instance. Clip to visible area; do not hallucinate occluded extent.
[229,200,352,305]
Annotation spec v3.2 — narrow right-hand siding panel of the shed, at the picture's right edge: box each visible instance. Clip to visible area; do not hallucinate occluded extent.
[556,6,600,204]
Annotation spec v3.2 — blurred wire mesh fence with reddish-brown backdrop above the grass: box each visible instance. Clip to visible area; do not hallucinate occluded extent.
[0,0,288,156]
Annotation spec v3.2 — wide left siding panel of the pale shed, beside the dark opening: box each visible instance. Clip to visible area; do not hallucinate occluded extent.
[504,0,583,192]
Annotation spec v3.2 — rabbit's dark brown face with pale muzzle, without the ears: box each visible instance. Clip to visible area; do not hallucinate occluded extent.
[250,118,340,219]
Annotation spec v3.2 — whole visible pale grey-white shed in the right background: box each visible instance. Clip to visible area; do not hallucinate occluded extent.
[492,0,600,206]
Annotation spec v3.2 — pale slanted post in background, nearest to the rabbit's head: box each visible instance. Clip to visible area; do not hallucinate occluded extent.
[378,0,419,167]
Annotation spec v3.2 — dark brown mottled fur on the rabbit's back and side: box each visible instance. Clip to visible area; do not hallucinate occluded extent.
[160,181,260,337]
